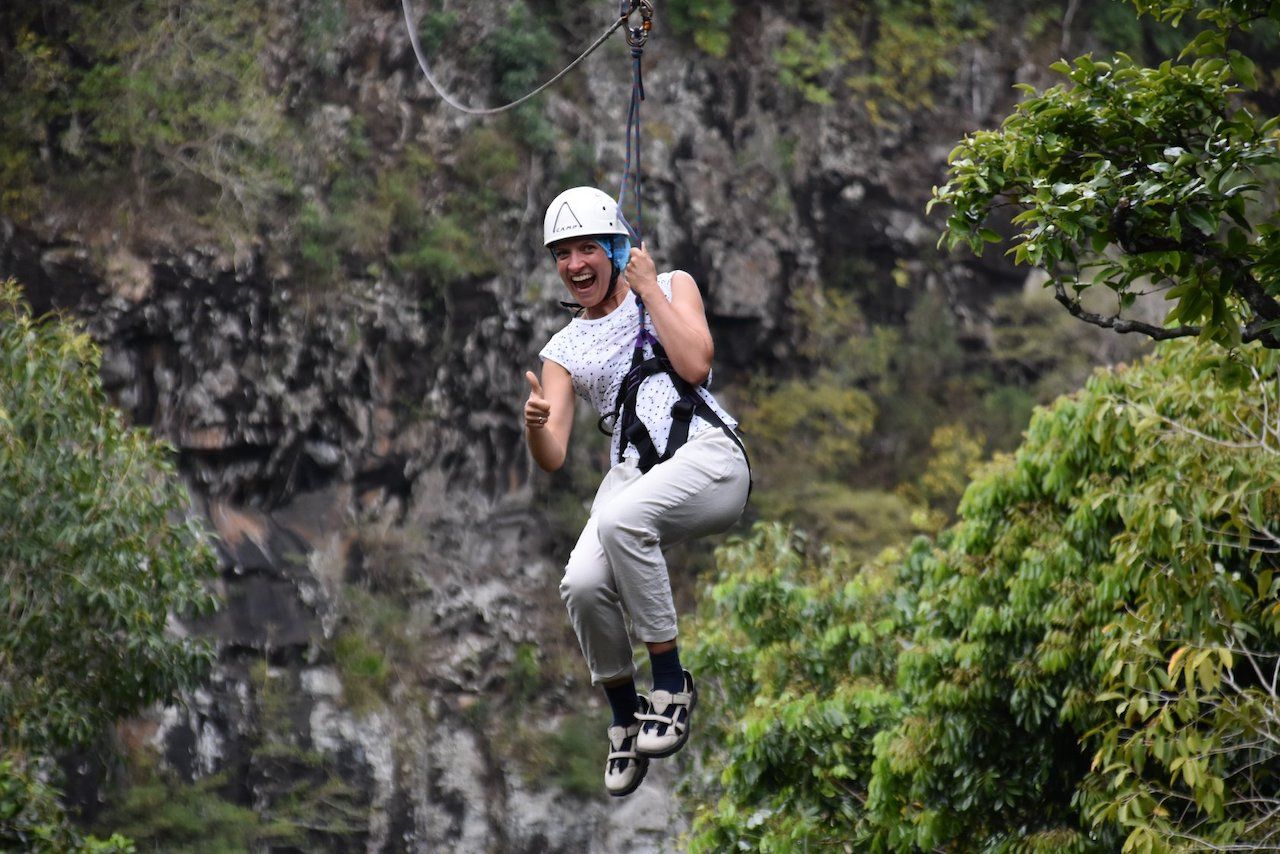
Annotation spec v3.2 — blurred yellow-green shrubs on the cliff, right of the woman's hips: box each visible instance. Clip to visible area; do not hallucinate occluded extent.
[741,282,1139,557]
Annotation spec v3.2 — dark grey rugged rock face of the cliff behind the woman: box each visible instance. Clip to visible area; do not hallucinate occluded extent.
[0,4,1049,851]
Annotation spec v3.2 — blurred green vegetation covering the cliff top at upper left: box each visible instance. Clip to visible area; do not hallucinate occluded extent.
[0,0,556,297]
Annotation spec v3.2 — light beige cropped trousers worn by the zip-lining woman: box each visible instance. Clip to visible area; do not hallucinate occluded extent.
[561,429,750,685]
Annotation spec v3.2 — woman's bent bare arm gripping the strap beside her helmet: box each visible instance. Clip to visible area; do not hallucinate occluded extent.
[626,245,714,385]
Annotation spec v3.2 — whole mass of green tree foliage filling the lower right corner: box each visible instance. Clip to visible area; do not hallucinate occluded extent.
[695,343,1280,851]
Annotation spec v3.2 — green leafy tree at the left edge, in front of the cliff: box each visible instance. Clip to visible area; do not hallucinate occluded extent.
[0,282,216,850]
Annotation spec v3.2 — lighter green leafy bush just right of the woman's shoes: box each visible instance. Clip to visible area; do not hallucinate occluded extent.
[691,524,915,851]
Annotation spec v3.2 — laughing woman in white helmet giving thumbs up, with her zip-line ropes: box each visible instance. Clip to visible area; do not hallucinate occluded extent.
[402,0,751,796]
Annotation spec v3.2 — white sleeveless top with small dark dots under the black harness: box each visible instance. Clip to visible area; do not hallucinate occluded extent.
[539,273,737,461]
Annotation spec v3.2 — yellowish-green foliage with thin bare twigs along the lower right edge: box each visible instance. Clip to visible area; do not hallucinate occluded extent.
[1088,352,1280,851]
